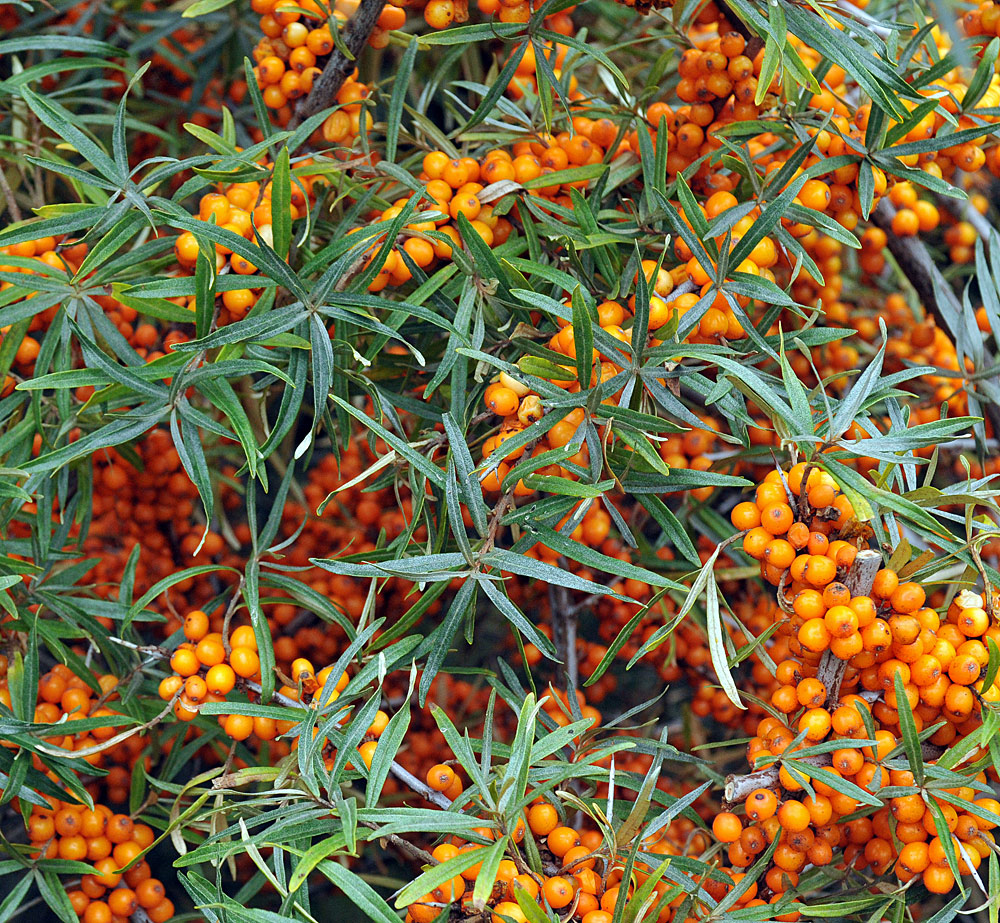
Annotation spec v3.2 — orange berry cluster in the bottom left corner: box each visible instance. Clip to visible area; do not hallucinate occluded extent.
[28,801,174,923]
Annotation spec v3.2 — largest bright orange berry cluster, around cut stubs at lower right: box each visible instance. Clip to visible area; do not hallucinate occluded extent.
[713,463,1000,893]
